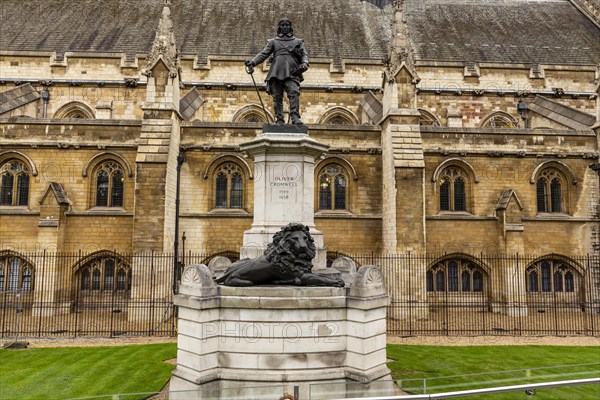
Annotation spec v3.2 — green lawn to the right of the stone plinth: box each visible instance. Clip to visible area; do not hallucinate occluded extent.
[387,345,600,400]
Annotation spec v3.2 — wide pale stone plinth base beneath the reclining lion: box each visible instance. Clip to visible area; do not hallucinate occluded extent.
[170,265,389,398]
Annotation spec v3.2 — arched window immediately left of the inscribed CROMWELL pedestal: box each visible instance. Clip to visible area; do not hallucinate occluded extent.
[215,163,244,208]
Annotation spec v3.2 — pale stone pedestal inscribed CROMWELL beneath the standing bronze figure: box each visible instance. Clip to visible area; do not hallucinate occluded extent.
[240,125,329,270]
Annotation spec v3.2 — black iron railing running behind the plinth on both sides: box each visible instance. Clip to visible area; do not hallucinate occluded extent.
[0,251,600,338]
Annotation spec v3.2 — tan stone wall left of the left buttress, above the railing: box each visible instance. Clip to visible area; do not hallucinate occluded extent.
[0,120,139,252]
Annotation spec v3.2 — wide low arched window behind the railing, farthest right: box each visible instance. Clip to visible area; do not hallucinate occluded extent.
[525,259,580,293]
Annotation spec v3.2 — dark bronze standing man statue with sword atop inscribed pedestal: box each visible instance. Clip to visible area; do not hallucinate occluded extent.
[245,18,308,125]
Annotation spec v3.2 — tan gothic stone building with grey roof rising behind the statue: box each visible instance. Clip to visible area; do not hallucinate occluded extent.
[0,0,600,318]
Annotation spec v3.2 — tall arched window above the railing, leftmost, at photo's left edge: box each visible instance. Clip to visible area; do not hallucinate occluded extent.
[0,160,29,206]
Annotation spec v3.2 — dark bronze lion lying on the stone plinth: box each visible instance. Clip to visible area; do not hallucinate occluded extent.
[216,223,344,287]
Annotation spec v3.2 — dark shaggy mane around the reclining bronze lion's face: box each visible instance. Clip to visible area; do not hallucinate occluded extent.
[265,223,317,275]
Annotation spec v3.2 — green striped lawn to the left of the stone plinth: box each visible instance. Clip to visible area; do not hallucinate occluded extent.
[0,343,177,400]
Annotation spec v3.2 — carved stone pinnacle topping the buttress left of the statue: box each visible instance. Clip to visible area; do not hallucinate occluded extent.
[142,0,181,78]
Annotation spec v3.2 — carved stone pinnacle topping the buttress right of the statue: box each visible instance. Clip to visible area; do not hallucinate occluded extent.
[383,0,421,84]
